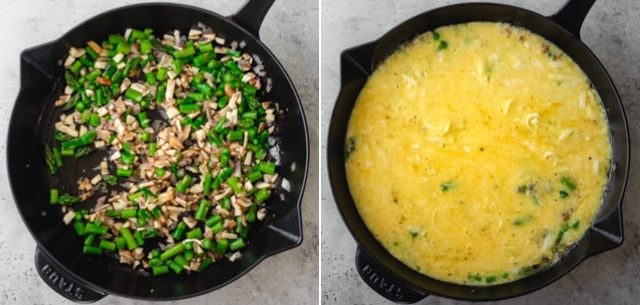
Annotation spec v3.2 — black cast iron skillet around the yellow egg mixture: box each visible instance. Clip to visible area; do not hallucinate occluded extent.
[327,0,630,303]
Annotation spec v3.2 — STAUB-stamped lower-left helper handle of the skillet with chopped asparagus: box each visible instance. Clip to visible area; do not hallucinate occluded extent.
[35,246,106,304]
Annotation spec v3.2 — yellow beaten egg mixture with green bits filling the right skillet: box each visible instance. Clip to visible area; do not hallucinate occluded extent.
[345,22,611,285]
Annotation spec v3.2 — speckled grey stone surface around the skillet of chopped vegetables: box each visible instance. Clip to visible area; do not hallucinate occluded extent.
[0,0,319,305]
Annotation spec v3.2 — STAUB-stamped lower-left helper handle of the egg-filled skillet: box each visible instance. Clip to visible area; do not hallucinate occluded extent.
[356,247,429,304]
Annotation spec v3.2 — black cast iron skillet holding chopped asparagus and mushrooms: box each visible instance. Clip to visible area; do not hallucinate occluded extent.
[7,0,308,303]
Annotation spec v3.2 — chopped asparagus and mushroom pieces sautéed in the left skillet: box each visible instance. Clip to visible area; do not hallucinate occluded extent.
[45,24,278,275]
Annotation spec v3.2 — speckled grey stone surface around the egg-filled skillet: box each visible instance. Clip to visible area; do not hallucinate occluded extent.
[321,0,640,305]
